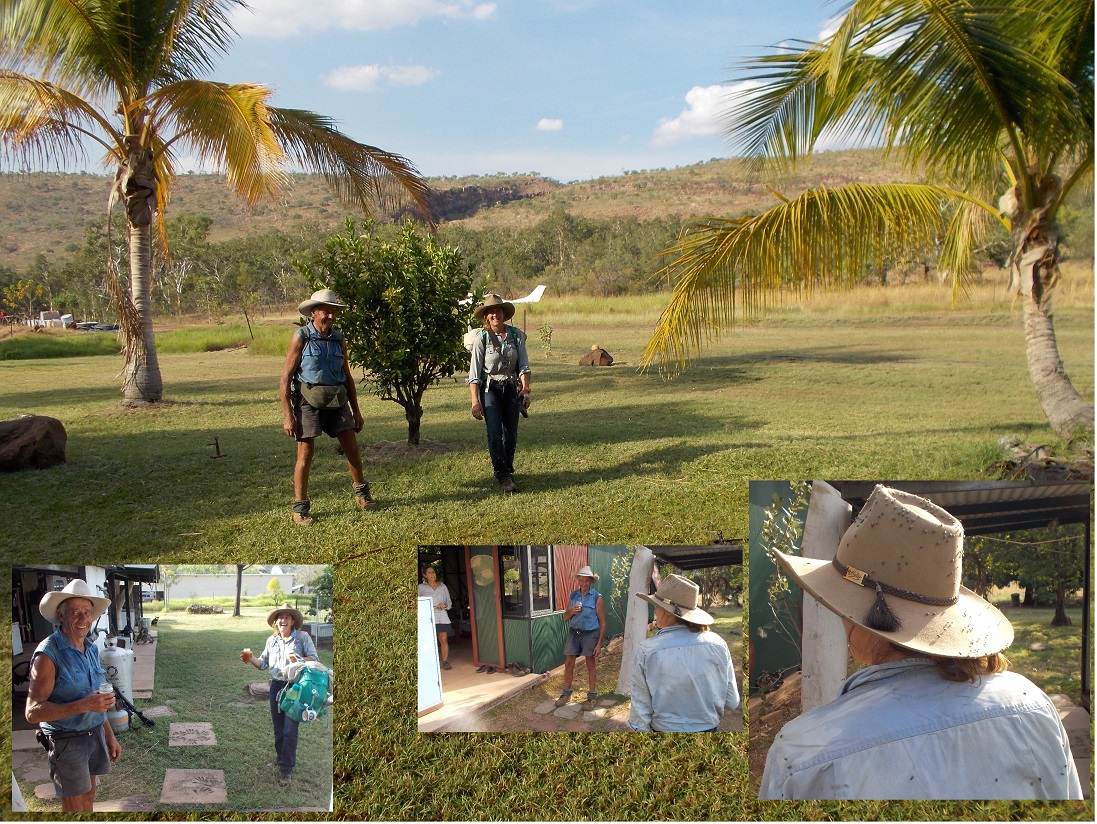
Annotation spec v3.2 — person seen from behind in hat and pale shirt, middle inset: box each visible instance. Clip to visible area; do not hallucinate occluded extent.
[629,575,739,733]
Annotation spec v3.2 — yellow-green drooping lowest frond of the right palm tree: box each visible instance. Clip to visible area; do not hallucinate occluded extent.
[641,183,971,374]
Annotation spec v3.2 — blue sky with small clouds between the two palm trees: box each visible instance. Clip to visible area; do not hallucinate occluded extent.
[204,0,841,182]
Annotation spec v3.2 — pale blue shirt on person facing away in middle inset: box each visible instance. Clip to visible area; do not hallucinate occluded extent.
[629,624,739,733]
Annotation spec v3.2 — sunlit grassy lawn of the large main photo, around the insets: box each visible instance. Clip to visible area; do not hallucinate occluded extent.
[0,287,1094,821]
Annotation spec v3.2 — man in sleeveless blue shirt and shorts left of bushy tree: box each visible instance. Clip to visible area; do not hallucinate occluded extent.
[279,289,377,527]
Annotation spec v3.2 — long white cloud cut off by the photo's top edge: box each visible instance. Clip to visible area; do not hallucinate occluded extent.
[231,0,496,37]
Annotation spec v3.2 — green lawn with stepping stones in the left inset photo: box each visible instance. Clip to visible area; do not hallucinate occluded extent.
[21,608,335,813]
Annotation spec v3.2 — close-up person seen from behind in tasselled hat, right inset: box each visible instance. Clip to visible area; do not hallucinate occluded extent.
[759,486,1082,800]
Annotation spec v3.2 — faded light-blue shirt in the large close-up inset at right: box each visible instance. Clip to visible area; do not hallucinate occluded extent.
[758,657,1082,800]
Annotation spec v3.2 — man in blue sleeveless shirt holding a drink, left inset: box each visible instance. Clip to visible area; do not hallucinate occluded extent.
[25,578,122,812]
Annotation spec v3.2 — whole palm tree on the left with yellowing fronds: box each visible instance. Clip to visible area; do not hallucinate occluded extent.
[0,0,430,404]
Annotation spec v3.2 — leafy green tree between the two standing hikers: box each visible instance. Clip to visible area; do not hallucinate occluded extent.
[301,221,474,445]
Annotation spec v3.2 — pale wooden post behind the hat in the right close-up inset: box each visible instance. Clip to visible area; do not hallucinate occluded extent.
[801,481,852,712]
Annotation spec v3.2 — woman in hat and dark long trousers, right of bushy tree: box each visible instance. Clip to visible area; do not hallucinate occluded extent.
[467,294,530,495]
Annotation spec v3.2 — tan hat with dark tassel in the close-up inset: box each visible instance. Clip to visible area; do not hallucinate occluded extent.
[773,485,1014,658]
